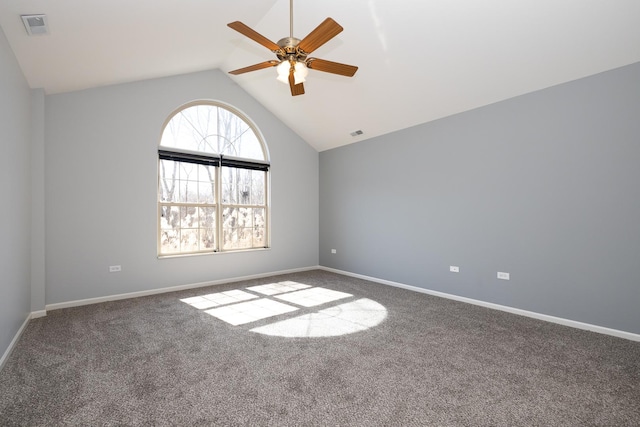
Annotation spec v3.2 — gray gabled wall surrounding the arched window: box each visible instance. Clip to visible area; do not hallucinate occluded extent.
[45,70,319,304]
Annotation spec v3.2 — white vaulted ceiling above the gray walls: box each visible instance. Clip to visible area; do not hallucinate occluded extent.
[0,0,640,151]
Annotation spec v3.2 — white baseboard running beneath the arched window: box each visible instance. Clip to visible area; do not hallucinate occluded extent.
[45,265,320,313]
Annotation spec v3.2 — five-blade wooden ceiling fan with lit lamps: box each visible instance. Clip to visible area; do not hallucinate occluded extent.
[227,0,358,96]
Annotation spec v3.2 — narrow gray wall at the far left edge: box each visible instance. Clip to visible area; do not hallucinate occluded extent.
[0,28,31,357]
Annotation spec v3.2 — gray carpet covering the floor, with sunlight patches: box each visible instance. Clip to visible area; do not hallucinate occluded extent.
[0,271,640,426]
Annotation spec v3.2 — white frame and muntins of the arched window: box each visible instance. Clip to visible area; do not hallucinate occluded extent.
[156,100,271,258]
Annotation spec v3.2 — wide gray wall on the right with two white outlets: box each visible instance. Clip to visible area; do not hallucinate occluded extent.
[320,64,640,333]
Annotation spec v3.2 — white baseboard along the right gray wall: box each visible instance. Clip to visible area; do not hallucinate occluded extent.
[319,266,640,341]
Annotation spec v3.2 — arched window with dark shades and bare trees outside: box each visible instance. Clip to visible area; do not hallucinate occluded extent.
[158,101,269,256]
